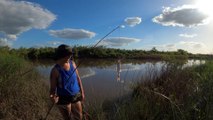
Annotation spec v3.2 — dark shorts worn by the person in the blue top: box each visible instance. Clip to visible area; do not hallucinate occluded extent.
[57,93,82,105]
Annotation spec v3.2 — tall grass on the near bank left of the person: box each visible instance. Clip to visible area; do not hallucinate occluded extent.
[0,53,61,120]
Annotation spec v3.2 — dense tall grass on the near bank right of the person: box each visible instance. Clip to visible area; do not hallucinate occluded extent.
[91,62,213,120]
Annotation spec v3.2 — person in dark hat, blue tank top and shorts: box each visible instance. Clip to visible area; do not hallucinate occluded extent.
[50,44,84,120]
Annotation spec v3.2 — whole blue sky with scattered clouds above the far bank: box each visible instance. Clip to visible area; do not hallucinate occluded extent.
[0,0,213,54]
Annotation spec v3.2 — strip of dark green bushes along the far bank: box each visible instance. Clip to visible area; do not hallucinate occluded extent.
[0,46,213,60]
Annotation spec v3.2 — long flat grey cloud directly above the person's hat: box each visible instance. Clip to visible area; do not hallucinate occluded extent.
[49,28,95,40]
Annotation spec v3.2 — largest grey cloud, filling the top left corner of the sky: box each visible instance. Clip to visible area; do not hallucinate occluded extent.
[0,0,56,44]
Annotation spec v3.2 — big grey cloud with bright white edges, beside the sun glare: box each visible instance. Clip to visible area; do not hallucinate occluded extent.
[152,5,209,27]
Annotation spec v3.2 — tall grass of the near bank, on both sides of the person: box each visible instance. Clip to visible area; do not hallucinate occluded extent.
[0,53,213,120]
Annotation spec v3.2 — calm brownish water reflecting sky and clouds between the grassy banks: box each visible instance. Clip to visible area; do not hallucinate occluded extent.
[37,59,205,103]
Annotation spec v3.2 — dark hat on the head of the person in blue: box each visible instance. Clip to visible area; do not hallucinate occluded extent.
[55,44,72,60]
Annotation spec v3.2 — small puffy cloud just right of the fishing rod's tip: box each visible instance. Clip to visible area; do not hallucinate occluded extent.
[124,17,142,27]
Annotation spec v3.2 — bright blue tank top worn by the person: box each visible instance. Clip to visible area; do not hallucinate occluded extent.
[55,61,80,96]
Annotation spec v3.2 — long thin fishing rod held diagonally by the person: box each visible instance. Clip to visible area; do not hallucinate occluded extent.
[43,25,124,120]
